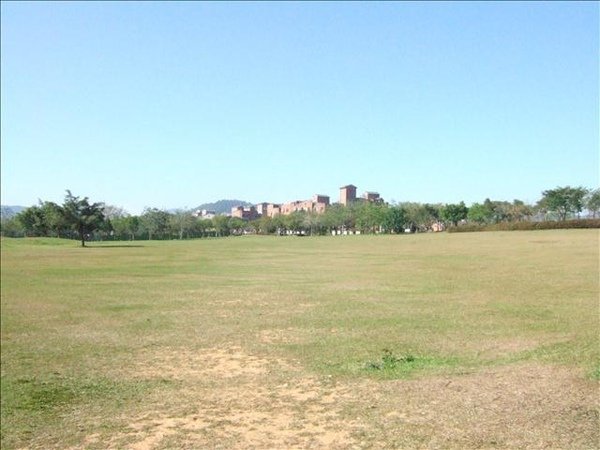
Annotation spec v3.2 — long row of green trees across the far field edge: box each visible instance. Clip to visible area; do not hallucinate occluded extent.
[1,186,600,246]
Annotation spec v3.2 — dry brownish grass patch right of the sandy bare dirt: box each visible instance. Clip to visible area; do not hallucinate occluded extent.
[354,364,600,449]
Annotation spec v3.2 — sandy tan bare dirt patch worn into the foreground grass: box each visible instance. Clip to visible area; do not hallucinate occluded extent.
[110,347,353,450]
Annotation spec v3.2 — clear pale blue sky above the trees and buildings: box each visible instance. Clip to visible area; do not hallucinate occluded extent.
[1,2,599,213]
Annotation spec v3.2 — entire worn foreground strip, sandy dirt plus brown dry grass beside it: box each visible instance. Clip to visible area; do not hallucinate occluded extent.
[97,346,599,450]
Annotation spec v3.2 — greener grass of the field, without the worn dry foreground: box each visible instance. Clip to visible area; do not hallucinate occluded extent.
[1,230,600,448]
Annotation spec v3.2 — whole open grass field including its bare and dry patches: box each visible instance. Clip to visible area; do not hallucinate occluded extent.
[1,230,600,449]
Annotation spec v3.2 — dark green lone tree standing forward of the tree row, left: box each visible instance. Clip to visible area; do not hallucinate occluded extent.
[62,191,105,247]
